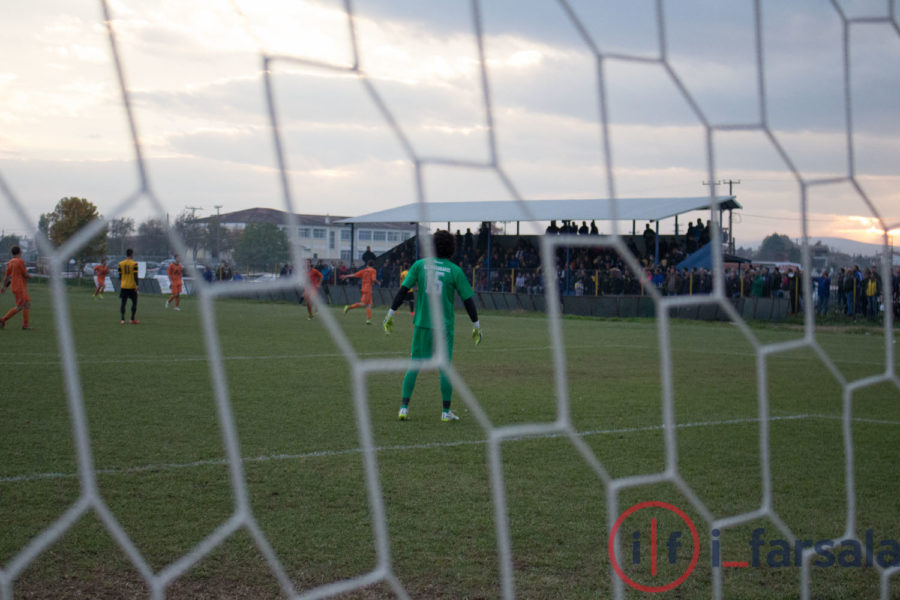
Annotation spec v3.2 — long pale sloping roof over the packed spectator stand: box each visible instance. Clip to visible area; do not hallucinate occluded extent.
[338,196,743,223]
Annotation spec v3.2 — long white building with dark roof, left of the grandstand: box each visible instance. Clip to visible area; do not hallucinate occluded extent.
[202,208,416,263]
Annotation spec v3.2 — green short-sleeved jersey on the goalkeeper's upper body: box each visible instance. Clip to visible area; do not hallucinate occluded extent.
[402,258,472,334]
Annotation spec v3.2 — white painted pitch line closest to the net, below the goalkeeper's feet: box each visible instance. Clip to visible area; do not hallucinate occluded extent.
[0,414,900,483]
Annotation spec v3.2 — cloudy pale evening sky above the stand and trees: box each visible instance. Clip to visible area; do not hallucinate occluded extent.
[0,0,900,246]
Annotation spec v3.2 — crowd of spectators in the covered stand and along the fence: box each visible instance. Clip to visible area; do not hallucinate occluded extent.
[264,219,900,319]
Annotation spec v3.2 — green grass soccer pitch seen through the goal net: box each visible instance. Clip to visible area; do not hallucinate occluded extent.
[0,284,900,598]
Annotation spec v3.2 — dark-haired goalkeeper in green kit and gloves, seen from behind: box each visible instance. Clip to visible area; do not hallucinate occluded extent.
[383,230,481,422]
